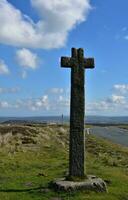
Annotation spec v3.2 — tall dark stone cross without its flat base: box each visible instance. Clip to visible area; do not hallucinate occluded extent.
[61,48,94,177]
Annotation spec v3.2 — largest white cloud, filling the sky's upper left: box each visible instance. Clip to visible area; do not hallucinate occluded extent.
[0,0,91,49]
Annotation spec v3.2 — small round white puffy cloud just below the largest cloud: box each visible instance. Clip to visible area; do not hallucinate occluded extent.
[16,48,39,69]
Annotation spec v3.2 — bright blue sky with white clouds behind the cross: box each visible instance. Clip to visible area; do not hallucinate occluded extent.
[0,0,128,116]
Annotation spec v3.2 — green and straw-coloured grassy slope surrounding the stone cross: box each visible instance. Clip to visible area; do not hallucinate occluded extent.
[0,126,128,200]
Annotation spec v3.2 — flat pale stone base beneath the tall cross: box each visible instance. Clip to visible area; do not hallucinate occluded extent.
[52,175,107,192]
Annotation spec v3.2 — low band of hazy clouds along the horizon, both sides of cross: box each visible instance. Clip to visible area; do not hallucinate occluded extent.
[0,86,128,115]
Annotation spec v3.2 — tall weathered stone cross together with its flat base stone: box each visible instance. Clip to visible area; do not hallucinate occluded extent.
[53,48,107,192]
